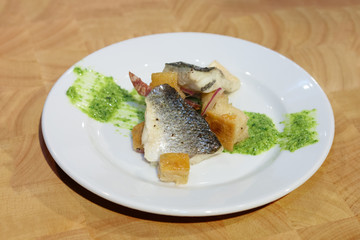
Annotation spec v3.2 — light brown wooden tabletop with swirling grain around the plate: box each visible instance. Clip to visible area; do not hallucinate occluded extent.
[0,0,360,240]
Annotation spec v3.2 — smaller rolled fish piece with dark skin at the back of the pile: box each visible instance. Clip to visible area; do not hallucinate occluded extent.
[163,62,240,93]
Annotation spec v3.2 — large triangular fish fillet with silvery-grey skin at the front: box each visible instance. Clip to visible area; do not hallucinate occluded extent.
[142,84,222,162]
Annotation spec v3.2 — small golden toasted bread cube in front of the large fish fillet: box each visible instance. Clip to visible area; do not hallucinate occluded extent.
[158,153,190,184]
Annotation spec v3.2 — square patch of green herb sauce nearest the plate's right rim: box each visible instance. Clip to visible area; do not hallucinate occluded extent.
[279,109,319,152]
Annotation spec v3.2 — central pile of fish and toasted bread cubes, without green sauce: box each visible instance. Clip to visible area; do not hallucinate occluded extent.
[129,61,248,184]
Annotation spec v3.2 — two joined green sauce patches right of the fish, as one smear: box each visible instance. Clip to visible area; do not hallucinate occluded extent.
[225,109,319,155]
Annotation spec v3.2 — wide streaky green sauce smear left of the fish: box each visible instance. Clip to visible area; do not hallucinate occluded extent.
[66,67,145,130]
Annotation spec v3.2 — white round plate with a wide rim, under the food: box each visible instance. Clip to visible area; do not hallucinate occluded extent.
[42,33,334,216]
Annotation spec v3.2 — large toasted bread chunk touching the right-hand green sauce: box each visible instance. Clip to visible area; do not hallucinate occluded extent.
[205,94,249,151]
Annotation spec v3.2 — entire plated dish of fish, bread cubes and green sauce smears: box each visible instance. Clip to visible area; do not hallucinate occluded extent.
[66,61,318,184]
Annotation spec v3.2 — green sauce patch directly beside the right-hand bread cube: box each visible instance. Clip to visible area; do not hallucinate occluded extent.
[231,112,279,155]
